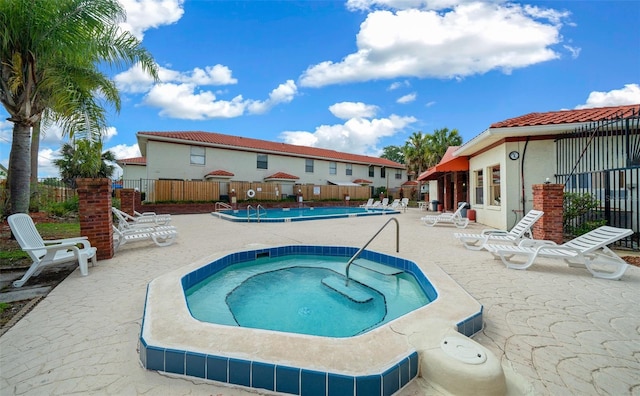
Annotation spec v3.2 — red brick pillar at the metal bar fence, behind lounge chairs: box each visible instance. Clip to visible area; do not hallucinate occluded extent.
[532,184,564,244]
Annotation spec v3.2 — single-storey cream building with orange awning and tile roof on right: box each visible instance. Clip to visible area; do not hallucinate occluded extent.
[418,104,640,238]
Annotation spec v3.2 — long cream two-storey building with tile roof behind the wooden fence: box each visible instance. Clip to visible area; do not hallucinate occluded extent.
[118,131,407,198]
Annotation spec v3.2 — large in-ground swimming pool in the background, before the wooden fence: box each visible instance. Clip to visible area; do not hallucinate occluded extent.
[211,206,400,222]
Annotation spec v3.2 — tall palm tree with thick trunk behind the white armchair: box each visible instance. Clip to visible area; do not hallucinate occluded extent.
[0,0,158,214]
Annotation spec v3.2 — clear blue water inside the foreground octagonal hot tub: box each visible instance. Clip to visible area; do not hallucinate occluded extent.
[185,255,430,337]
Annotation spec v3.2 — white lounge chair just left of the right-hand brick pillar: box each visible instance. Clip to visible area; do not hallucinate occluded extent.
[453,210,544,250]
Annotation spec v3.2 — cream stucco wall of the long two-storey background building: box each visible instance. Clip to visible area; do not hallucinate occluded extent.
[146,141,407,188]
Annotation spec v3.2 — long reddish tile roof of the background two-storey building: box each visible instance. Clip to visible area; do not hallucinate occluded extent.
[138,131,404,168]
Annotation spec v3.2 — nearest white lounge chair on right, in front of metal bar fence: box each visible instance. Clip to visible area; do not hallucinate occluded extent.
[484,226,633,280]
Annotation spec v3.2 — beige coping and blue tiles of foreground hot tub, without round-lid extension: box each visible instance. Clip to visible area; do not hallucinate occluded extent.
[140,245,482,395]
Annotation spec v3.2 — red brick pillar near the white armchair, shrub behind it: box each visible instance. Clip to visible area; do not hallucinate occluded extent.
[76,179,113,260]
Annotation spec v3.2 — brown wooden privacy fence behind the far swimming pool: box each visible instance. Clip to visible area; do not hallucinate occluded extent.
[145,180,371,202]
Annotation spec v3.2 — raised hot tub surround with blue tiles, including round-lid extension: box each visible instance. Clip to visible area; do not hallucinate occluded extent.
[139,245,505,396]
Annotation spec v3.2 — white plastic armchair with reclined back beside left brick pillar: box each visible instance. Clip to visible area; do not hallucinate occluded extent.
[7,213,97,287]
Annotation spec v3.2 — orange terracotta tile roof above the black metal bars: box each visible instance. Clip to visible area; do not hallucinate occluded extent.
[491,104,640,128]
